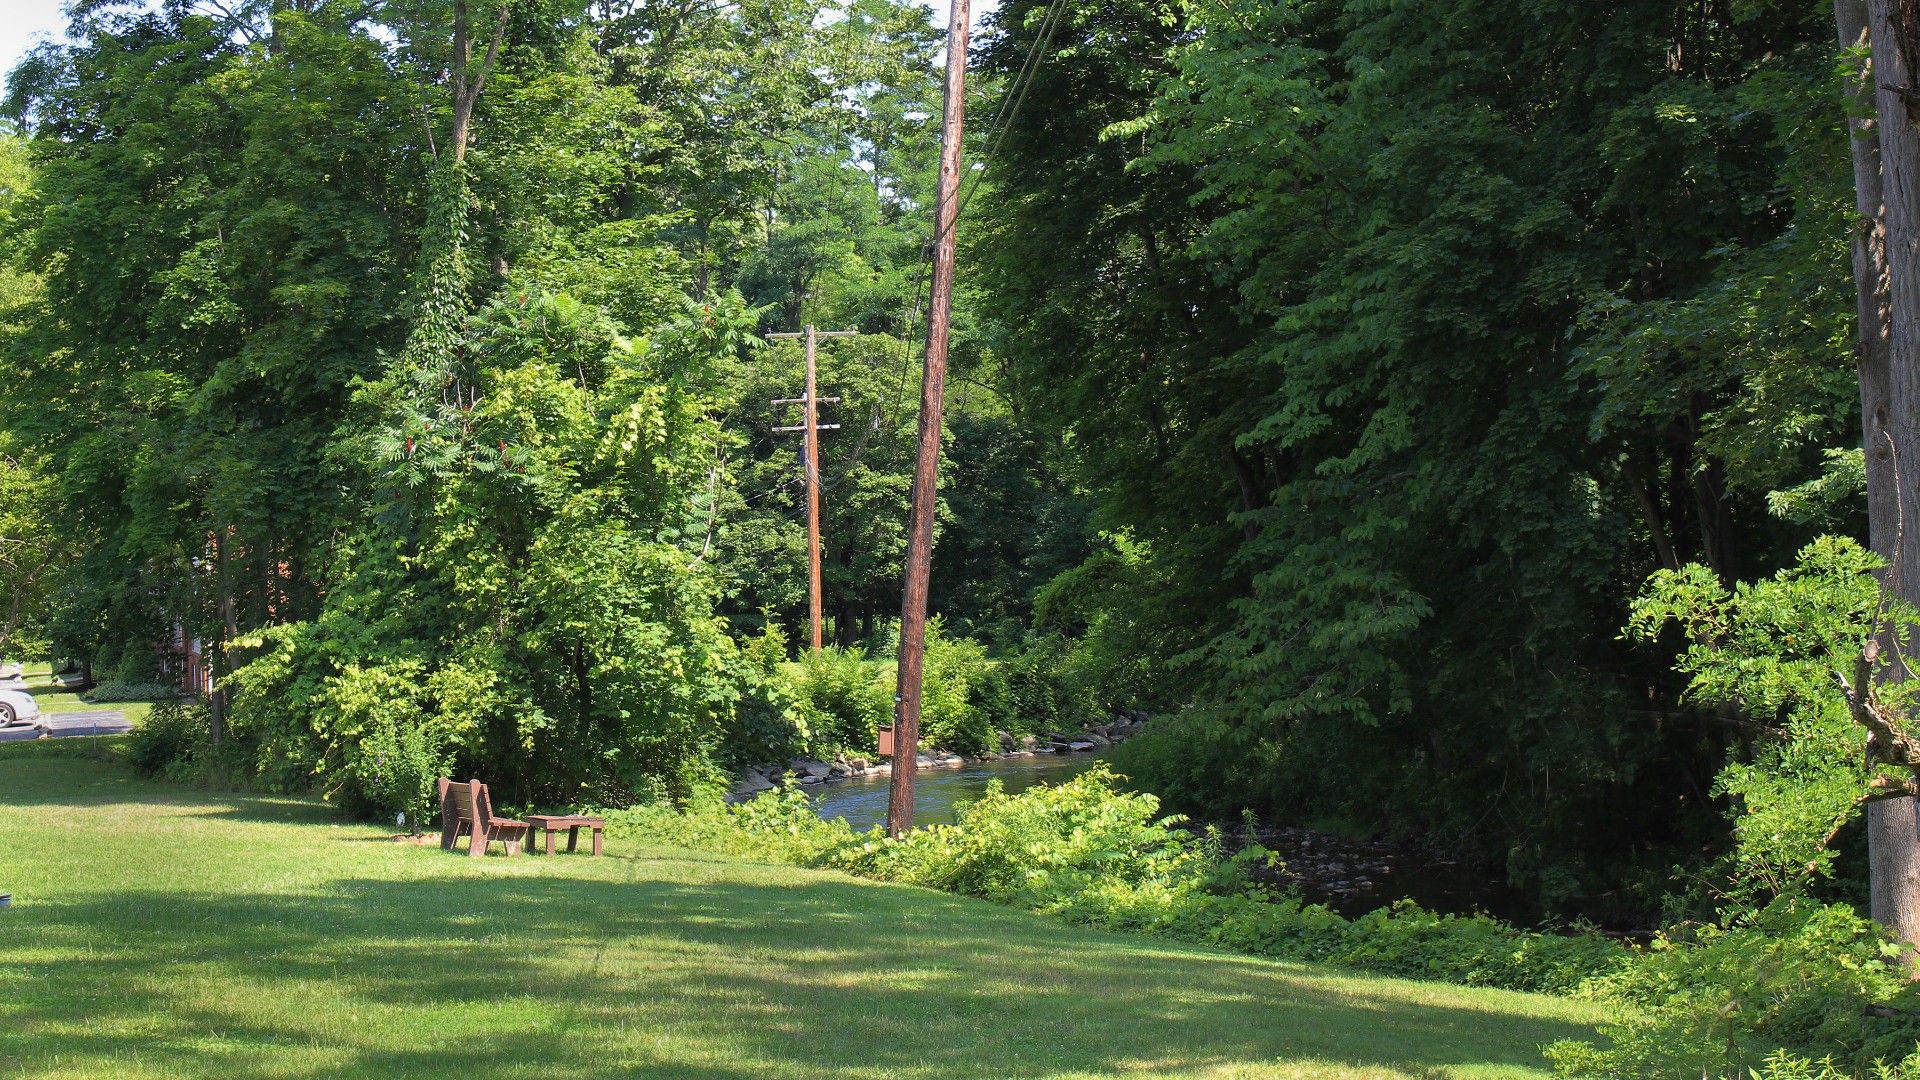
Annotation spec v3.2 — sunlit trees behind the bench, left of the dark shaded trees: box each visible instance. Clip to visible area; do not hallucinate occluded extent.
[0,0,1083,807]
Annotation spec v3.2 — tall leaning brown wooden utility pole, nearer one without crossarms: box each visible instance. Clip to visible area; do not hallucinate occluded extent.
[887,0,972,836]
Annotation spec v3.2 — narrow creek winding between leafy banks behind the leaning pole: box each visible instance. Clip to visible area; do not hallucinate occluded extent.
[808,753,1538,922]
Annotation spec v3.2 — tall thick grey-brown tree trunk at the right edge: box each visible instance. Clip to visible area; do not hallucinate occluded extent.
[1834,0,1920,957]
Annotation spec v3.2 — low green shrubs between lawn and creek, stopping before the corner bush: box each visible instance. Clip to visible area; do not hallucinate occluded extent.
[607,765,1630,994]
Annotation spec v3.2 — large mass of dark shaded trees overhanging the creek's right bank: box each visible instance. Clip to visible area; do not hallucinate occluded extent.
[990,0,1862,903]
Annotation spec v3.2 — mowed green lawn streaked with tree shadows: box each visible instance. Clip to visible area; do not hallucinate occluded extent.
[0,740,1597,1080]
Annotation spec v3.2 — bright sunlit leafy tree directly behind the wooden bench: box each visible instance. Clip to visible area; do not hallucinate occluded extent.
[236,296,737,811]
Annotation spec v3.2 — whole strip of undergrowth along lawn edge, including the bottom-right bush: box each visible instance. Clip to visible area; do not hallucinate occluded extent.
[607,765,1920,1080]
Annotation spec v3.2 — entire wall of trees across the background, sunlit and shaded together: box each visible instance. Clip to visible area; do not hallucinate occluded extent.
[0,0,1904,909]
